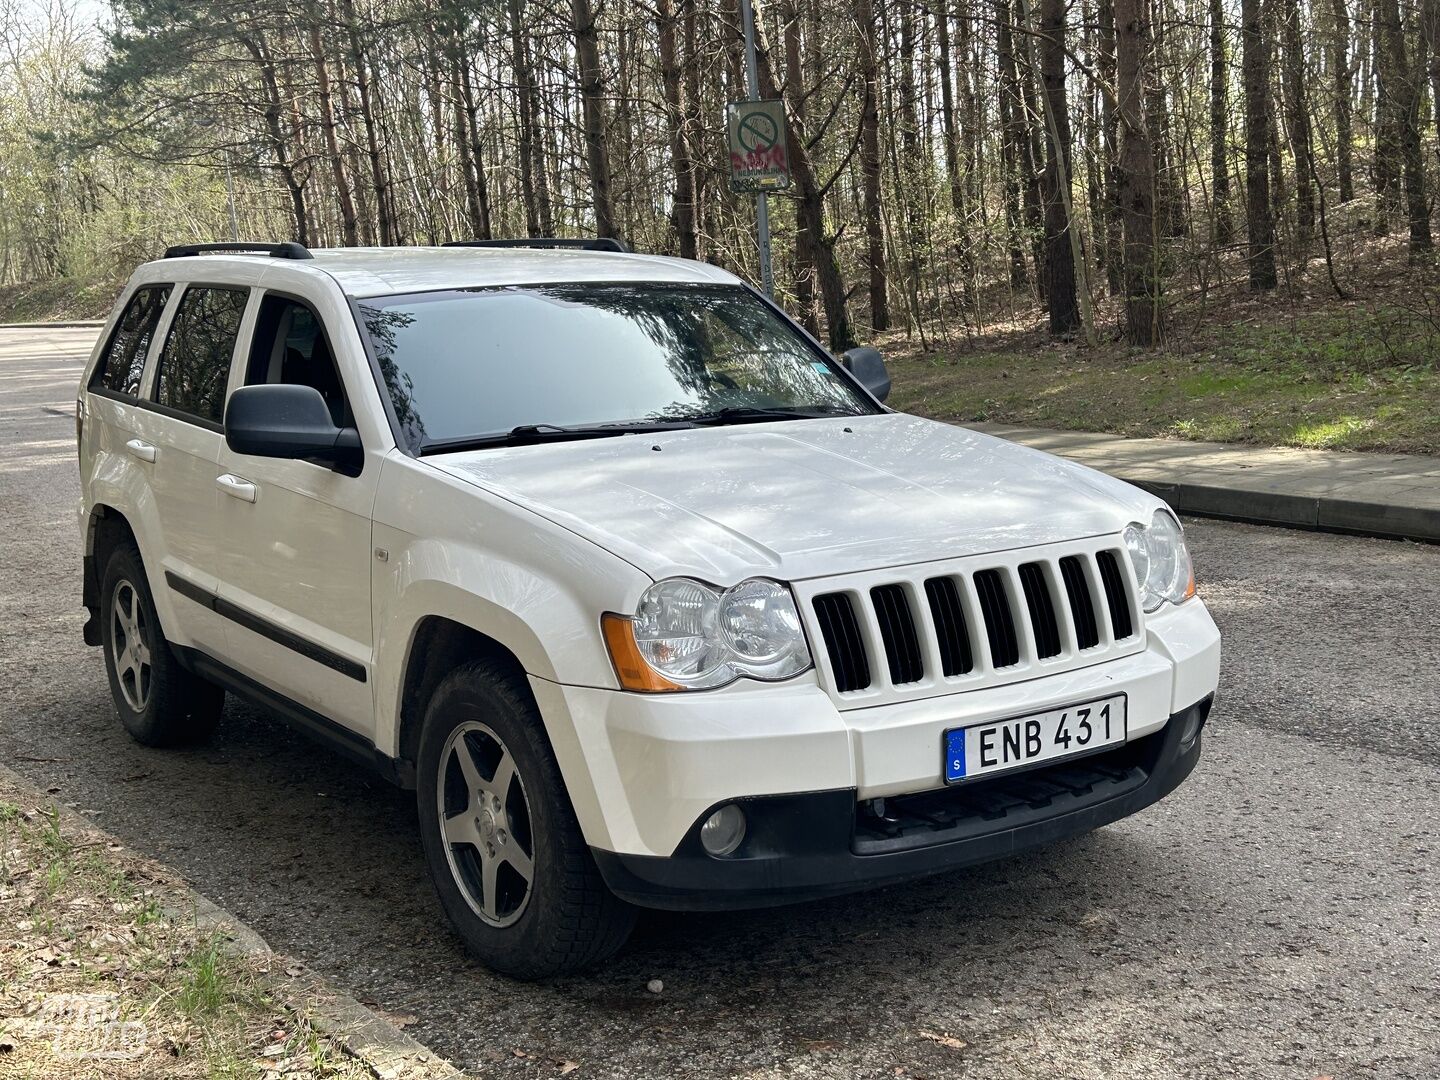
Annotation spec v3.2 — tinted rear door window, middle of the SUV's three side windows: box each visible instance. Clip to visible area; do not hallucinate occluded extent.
[154,285,249,425]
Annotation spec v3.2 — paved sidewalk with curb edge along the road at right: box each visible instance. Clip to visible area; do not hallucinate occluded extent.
[966,423,1440,543]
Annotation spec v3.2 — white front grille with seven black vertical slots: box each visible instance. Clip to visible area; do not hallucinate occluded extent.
[806,541,1139,703]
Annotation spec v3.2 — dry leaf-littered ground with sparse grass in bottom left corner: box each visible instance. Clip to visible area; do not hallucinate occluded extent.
[0,776,370,1080]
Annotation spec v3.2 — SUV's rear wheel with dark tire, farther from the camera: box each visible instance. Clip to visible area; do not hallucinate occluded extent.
[101,540,225,746]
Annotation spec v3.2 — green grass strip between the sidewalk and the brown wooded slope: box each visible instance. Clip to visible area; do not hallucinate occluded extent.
[887,305,1440,454]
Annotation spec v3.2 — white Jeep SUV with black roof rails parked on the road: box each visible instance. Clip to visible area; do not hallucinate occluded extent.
[78,240,1220,978]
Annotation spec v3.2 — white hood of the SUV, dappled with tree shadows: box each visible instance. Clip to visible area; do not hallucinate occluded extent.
[425,413,1159,585]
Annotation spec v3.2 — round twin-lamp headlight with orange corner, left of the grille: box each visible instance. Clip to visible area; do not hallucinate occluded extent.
[603,577,811,690]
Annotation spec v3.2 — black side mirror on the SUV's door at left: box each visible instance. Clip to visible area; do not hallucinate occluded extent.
[225,383,361,469]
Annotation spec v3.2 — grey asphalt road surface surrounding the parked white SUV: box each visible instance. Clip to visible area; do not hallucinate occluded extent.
[0,331,1440,1080]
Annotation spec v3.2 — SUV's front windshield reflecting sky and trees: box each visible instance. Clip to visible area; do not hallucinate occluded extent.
[360,284,877,454]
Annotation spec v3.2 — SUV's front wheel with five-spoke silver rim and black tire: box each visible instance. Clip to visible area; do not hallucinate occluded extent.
[416,660,635,979]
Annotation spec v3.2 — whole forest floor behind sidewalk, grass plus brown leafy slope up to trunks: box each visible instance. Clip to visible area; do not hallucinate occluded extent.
[877,233,1440,454]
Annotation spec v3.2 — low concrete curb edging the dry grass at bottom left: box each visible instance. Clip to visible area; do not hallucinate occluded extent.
[0,765,468,1080]
